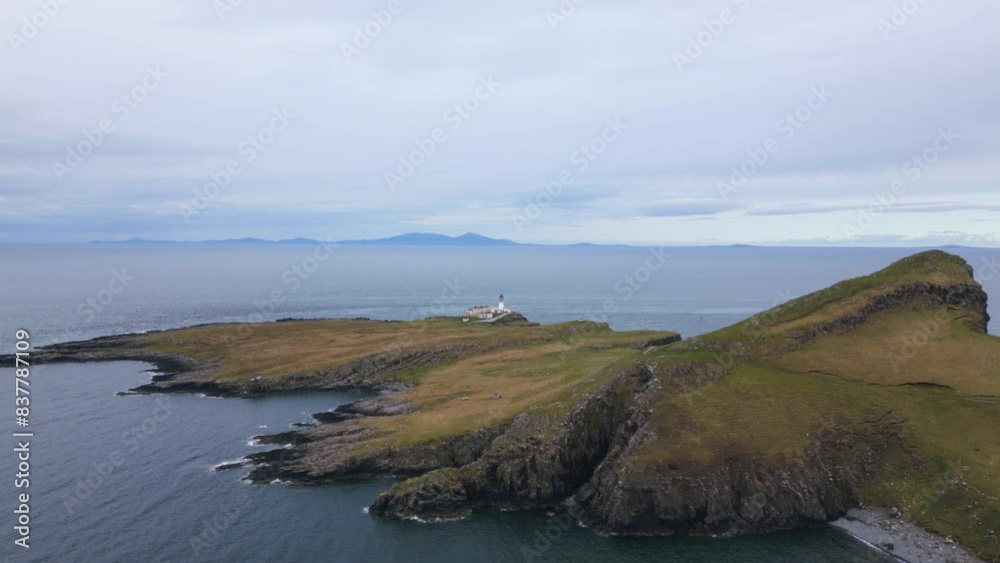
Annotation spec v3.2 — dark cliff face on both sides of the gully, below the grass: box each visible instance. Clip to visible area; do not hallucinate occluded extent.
[371,352,899,534]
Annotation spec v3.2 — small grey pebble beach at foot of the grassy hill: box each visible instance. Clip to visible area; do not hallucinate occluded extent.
[830,508,986,563]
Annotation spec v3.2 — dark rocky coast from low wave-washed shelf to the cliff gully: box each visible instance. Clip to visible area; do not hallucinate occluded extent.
[249,362,652,494]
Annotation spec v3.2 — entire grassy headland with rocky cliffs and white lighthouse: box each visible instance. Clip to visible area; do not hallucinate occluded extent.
[15,252,1000,561]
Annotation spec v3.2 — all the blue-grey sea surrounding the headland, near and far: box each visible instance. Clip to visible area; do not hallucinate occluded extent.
[0,245,1000,562]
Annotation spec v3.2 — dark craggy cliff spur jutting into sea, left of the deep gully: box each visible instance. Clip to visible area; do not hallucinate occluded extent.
[362,362,725,518]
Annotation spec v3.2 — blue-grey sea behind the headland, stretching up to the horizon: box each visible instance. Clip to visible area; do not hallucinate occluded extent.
[0,244,1000,344]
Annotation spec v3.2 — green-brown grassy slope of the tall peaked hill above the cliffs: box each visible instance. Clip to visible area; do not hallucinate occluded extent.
[627,251,1000,560]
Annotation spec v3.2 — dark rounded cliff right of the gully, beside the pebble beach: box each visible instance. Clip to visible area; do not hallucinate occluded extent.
[573,417,898,534]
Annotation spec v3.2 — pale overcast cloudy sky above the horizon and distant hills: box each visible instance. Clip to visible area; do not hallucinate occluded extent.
[0,0,1000,246]
